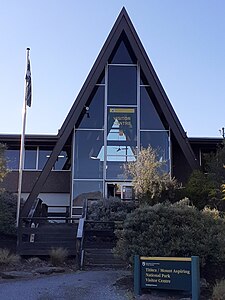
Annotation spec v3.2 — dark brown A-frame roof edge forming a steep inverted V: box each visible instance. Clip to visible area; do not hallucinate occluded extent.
[22,8,198,216]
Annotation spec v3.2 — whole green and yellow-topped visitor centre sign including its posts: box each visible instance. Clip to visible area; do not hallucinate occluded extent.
[134,255,200,300]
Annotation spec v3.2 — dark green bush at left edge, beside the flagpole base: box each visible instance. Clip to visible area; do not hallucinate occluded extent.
[0,191,17,235]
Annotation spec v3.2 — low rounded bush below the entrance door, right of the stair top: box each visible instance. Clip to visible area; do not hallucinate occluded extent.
[87,197,136,221]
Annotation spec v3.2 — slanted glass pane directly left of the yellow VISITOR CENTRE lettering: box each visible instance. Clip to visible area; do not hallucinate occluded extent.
[76,86,105,129]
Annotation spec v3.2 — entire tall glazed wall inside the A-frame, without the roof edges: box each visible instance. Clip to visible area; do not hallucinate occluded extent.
[72,33,170,202]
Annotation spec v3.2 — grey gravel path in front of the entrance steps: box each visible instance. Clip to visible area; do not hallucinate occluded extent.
[0,270,130,300]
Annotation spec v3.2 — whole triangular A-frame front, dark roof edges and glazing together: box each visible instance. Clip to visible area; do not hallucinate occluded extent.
[22,8,198,216]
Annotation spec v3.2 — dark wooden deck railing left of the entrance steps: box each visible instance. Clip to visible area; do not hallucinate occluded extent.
[17,199,78,255]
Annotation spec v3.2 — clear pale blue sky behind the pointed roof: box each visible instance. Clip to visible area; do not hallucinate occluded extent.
[0,0,225,137]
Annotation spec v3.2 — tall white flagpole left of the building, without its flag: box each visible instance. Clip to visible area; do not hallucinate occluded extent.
[16,48,30,227]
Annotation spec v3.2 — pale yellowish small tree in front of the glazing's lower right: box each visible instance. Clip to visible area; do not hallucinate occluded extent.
[126,146,178,205]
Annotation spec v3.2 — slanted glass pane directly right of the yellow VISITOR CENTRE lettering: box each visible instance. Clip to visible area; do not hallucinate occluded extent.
[141,87,165,130]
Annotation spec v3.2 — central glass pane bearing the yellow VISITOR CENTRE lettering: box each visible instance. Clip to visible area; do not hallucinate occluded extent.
[107,107,137,142]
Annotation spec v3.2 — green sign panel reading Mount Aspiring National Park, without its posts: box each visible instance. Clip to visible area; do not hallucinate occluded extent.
[140,257,191,291]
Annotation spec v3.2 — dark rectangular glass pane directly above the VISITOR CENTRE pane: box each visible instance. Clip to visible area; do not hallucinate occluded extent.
[108,66,137,105]
